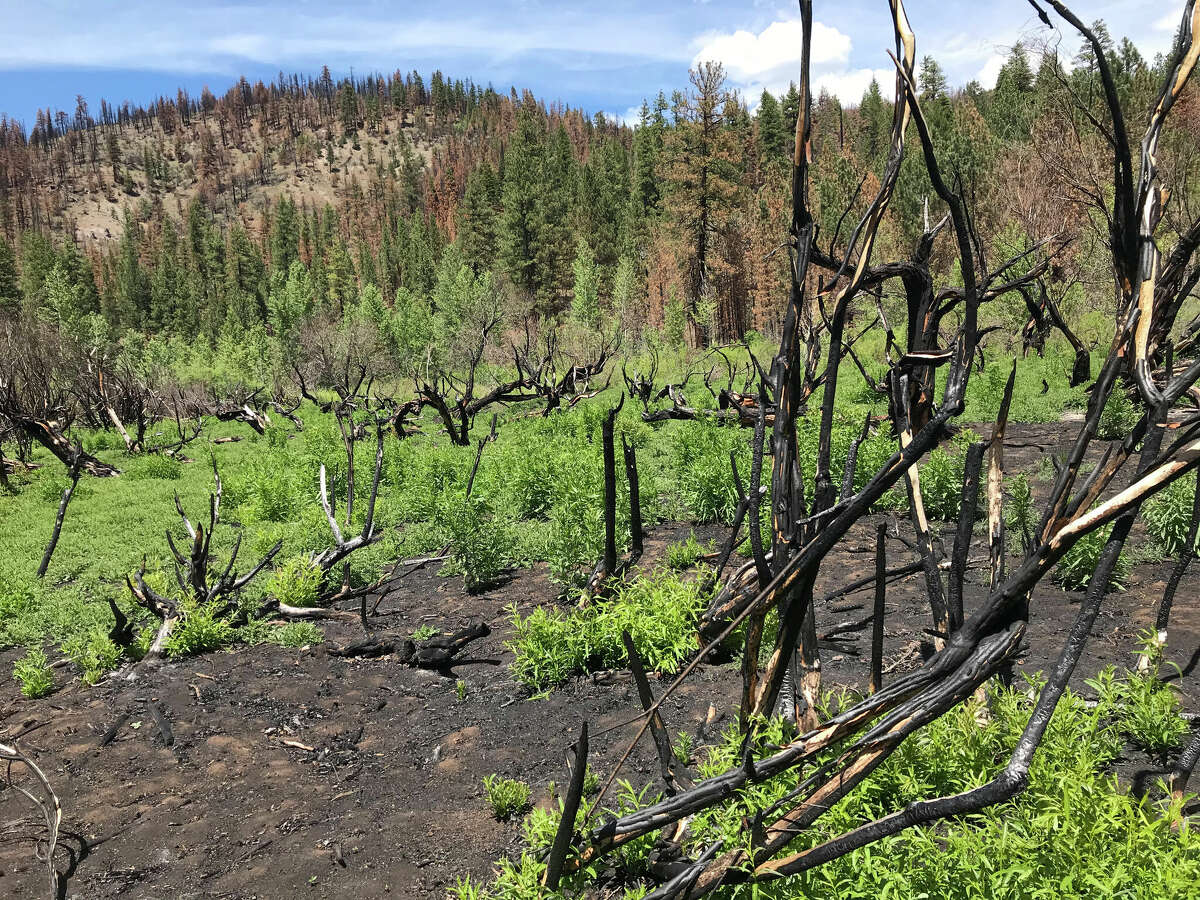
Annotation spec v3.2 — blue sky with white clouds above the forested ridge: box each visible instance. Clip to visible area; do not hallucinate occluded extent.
[0,0,1182,125]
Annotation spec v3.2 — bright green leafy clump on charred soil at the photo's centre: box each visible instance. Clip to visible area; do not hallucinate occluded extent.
[509,571,707,690]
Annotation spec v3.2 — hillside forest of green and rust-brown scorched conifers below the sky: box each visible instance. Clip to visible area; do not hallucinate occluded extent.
[0,24,1200,344]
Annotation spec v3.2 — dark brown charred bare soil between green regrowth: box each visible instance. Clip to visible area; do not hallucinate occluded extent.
[0,425,1200,900]
